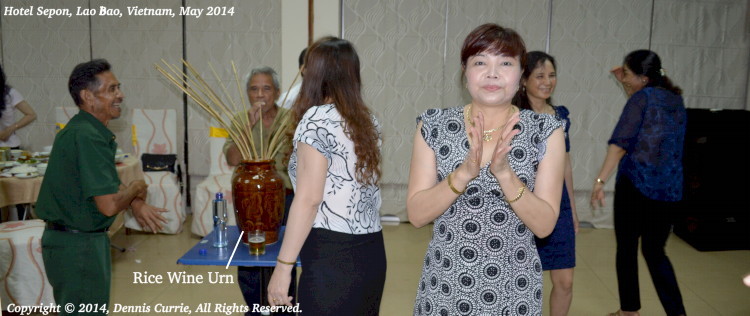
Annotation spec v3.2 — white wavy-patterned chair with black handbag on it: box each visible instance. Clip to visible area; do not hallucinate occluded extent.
[125,109,186,234]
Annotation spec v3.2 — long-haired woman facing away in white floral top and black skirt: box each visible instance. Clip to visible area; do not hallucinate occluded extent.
[268,37,386,315]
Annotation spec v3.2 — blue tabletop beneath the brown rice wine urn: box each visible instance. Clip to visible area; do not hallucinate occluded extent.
[177,226,300,267]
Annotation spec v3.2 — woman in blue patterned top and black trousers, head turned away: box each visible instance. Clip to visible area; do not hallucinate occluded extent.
[591,50,687,316]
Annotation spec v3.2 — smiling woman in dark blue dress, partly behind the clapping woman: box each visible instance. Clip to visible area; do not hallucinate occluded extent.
[513,51,578,316]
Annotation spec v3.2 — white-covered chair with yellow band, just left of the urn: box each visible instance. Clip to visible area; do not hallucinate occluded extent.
[191,127,237,236]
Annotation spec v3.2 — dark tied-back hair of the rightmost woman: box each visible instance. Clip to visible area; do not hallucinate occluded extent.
[623,49,682,95]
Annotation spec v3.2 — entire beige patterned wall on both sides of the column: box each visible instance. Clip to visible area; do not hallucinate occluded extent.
[0,0,750,227]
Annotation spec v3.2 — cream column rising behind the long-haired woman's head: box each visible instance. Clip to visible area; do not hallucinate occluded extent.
[277,0,341,91]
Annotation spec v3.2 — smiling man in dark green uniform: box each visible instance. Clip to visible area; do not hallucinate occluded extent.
[36,59,166,314]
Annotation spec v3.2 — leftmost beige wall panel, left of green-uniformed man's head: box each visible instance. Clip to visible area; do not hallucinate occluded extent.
[0,0,89,151]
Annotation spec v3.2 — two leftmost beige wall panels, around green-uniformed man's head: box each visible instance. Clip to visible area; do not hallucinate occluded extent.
[0,0,184,170]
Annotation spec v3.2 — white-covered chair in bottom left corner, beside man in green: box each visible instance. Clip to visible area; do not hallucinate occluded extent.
[0,219,55,310]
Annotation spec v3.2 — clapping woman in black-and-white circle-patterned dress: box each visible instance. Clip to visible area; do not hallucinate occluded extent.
[407,24,565,315]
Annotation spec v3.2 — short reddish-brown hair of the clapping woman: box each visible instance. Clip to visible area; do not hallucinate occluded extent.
[461,23,526,68]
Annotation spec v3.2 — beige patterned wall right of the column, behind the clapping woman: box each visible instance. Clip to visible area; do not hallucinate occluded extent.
[342,0,750,227]
